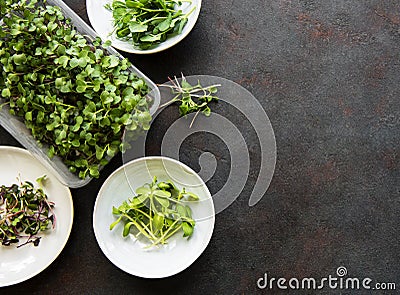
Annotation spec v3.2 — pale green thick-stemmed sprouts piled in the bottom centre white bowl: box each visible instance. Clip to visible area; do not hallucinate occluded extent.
[110,177,199,246]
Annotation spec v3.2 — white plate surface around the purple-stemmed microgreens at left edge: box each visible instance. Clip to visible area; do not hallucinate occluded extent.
[0,146,74,293]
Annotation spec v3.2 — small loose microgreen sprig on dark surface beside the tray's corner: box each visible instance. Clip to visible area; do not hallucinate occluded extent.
[159,75,221,126]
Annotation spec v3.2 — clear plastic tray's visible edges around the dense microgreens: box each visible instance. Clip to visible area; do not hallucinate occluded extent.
[0,0,160,188]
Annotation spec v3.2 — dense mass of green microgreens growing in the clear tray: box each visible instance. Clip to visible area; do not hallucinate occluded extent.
[0,0,151,178]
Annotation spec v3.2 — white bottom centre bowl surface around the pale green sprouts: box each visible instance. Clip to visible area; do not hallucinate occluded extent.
[93,156,215,278]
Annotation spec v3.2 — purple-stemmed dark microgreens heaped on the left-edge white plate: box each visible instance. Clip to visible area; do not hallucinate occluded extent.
[0,176,56,247]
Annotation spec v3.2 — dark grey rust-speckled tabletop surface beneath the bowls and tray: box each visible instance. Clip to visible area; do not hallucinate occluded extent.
[0,0,400,294]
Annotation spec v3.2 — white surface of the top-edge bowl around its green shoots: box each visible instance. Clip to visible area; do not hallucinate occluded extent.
[86,0,201,54]
